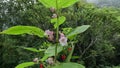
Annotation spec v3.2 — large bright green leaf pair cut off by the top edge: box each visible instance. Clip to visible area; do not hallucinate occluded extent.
[39,0,79,9]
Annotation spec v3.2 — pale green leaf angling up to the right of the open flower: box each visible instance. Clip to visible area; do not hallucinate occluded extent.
[67,25,90,38]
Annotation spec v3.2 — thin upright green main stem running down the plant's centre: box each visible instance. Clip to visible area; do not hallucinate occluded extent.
[55,0,59,62]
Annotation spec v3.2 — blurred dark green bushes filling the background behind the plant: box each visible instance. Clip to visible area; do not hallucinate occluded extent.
[0,0,120,68]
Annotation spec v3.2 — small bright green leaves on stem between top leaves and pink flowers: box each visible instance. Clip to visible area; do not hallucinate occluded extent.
[51,16,66,28]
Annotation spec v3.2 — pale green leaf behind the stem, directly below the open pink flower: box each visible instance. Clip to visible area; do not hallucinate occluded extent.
[45,45,63,56]
